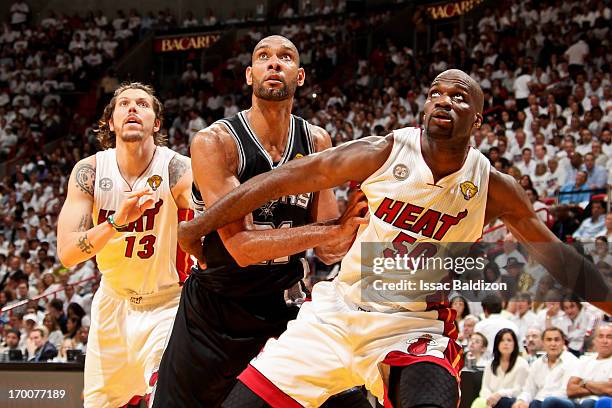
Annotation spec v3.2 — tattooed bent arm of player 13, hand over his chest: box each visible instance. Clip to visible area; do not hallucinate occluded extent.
[57,156,152,267]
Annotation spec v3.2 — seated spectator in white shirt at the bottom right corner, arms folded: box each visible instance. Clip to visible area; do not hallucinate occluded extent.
[542,323,612,408]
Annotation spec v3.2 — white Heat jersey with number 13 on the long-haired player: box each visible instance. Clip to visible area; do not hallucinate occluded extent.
[93,146,179,297]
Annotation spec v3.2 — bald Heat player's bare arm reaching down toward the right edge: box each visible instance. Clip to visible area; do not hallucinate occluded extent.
[485,169,612,313]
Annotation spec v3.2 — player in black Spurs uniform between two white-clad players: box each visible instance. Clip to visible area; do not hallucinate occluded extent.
[153,36,367,408]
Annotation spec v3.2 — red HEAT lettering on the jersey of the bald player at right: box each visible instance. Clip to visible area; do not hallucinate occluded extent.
[374,197,468,241]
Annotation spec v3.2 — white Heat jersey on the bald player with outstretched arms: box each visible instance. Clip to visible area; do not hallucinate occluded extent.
[336,127,491,310]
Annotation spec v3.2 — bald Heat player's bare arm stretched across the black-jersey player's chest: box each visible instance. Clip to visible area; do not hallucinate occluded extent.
[179,135,393,244]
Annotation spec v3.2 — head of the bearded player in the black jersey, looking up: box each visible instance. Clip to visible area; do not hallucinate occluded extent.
[246,35,305,101]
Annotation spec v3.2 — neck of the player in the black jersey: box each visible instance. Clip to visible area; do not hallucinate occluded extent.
[247,97,293,148]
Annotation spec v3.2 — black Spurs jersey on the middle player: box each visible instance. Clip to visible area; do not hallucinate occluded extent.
[192,111,315,296]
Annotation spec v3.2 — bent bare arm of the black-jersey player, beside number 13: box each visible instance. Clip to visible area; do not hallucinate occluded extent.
[178,125,372,266]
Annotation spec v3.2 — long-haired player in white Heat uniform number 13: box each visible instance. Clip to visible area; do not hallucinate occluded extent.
[57,83,192,408]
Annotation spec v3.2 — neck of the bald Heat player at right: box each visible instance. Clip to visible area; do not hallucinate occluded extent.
[421,134,469,183]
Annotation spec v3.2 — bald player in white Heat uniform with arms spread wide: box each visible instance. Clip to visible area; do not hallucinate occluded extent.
[179,70,609,408]
